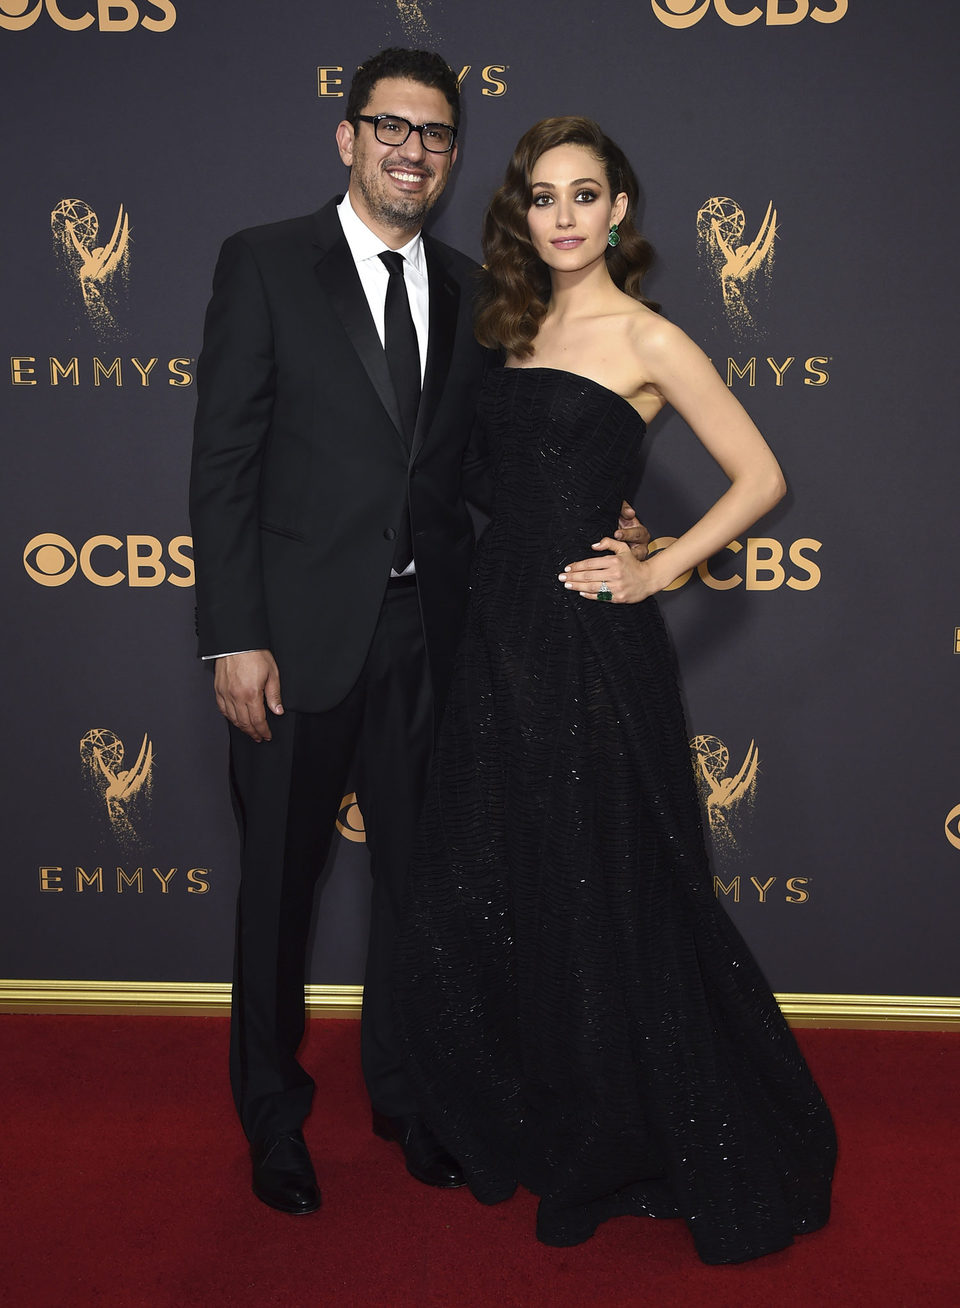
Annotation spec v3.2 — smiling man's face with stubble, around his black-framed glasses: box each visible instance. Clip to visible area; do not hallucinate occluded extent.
[336,77,456,239]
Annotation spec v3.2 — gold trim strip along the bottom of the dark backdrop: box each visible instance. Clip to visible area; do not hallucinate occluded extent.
[0,980,960,1031]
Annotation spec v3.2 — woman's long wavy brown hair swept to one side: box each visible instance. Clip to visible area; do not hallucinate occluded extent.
[473,116,659,358]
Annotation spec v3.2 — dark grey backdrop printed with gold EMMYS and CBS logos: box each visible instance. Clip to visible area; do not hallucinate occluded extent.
[0,0,960,995]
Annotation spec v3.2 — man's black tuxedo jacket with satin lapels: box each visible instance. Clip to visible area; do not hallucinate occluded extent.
[190,200,496,712]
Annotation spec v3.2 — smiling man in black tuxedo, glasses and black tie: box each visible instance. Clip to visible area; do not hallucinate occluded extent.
[191,50,651,1213]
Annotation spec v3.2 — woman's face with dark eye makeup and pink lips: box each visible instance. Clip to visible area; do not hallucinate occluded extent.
[527,145,626,272]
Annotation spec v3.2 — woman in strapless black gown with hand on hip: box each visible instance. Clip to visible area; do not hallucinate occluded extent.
[398,118,836,1262]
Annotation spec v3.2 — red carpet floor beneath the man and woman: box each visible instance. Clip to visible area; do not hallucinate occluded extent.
[0,1016,960,1308]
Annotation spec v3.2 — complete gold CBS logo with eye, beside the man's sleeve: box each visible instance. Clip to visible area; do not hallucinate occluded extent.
[24,531,194,587]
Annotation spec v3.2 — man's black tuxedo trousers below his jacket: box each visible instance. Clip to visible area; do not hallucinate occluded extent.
[230,579,433,1139]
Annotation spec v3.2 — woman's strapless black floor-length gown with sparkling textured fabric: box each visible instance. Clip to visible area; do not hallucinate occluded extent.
[396,368,836,1262]
